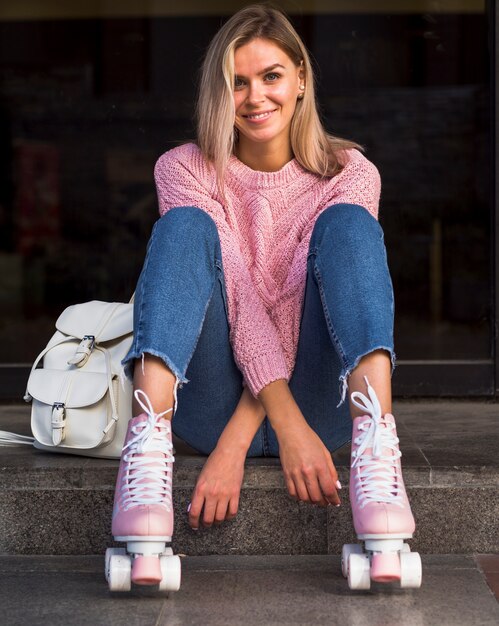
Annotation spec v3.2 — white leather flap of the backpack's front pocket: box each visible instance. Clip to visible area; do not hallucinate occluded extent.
[28,369,108,409]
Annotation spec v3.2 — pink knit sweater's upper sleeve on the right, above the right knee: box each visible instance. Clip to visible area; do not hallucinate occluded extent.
[323,149,381,219]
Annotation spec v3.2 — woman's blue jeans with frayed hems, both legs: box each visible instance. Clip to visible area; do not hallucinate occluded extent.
[123,204,394,456]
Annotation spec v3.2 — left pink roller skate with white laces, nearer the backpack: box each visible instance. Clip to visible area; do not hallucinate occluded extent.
[106,390,180,591]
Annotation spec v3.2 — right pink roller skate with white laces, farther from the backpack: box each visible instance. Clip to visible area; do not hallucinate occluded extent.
[341,377,422,589]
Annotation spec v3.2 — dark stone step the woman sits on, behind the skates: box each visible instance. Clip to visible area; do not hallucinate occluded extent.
[0,401,499,555]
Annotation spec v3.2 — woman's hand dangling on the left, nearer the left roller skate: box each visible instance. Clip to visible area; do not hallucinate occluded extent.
[189,446,246,530]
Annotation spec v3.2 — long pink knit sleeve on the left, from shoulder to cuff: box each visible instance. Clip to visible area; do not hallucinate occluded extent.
[154,150,289,397]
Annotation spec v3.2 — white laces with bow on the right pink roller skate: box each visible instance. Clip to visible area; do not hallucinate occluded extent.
[351,376,404,508]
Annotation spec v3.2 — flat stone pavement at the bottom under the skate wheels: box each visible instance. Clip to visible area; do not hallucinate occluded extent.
[0,555,499,626]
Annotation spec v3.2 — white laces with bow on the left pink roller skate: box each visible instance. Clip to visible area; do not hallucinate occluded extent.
[121,389,175,511]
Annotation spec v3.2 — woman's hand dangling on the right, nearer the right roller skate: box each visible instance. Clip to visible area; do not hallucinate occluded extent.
[278,420,341,506]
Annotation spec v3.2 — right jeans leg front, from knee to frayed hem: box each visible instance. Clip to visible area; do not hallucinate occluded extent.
[308,204,395,402]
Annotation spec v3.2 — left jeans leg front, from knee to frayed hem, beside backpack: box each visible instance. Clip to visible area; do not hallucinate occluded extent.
[122,207,222,383]
